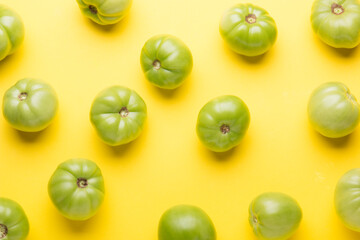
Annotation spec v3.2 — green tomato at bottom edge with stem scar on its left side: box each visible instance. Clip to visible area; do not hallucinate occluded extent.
[249,192,302,240]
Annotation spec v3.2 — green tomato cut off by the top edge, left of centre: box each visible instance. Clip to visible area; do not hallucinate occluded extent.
[76,0,132,25]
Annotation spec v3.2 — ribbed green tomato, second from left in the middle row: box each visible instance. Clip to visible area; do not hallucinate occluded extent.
[90,86,147,146]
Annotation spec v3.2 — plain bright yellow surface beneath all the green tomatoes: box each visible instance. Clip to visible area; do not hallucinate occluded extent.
[0,0,360,240]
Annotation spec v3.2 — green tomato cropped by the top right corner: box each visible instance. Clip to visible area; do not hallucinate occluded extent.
[311,0,360,48]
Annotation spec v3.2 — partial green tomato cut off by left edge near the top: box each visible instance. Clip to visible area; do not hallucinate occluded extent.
[0,5,25,61]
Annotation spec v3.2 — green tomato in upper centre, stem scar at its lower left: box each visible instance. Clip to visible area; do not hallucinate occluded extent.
[140,35,193,89]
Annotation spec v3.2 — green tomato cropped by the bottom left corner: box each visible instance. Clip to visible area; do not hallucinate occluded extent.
[0,198,29,240]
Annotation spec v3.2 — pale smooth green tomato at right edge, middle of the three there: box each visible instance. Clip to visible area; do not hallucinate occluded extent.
[308,82,360,138]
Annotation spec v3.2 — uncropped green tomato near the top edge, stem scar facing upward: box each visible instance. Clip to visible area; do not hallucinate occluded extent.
[220,3,277,56]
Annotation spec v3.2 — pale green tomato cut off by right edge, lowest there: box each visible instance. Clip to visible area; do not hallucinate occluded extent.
[334,168,360,232]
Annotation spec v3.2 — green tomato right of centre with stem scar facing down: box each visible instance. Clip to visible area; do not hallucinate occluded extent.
[196,95,250,152]
